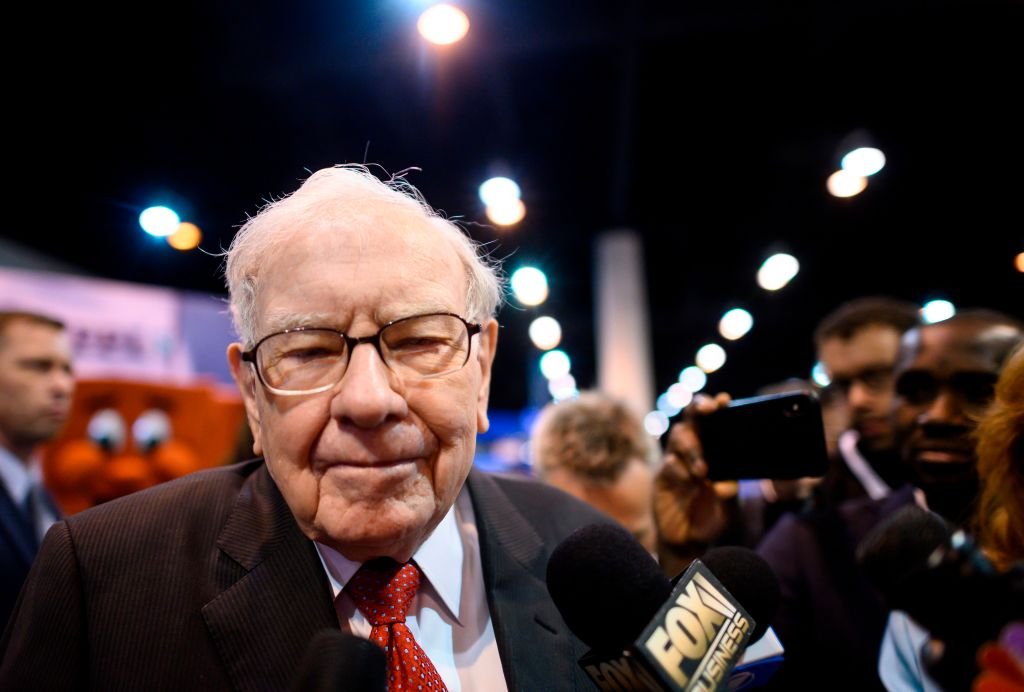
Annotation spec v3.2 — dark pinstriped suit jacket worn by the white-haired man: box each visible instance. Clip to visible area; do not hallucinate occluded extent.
[0,460,609,691]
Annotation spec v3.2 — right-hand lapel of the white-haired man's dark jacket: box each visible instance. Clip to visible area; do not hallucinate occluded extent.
[467,470,581,690]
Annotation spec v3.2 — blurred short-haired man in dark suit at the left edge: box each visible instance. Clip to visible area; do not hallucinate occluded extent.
[0,311,75,626]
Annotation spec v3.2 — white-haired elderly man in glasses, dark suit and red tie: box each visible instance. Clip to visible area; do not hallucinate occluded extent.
[0,167,607,690]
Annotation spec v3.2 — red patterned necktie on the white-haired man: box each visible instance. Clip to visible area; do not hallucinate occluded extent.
[345,558,447,692]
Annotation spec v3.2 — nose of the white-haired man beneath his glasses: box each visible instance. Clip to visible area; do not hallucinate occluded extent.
[331,344,409,428]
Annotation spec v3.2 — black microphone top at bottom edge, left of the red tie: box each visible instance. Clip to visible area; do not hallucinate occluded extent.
[289,629,387,692]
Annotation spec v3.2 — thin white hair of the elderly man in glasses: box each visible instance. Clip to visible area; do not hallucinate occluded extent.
[224,164,504,348]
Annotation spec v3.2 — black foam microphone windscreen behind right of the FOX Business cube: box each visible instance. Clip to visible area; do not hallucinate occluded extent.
[700,546,782,642]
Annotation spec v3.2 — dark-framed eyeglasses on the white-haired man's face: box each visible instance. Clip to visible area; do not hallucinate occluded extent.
[242,312,480,396]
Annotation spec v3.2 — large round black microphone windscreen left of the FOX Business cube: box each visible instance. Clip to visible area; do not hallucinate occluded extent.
[547,524,672,651]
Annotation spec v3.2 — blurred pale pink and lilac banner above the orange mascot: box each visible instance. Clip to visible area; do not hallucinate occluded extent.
[0,267,234,384]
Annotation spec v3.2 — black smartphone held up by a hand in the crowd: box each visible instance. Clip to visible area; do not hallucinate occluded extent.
[694,392,828,480]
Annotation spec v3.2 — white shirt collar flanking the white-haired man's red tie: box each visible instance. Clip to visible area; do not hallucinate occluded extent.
[314,487,469,621]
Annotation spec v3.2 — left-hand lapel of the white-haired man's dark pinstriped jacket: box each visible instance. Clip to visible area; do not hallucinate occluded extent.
[203,466,339,690]
